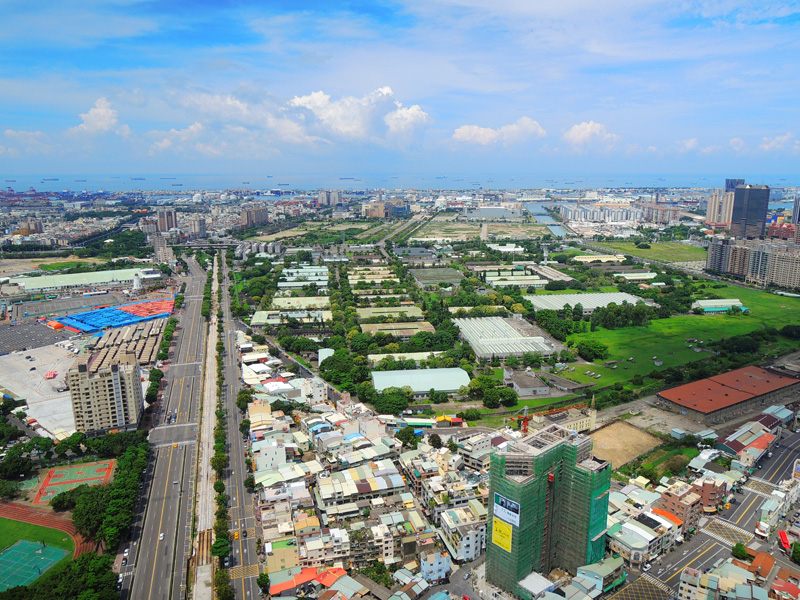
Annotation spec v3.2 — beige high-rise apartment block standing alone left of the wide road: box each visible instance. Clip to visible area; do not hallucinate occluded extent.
[67,354,143,434]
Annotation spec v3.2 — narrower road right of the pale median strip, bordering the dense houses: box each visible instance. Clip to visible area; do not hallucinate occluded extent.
[221,260,261,600]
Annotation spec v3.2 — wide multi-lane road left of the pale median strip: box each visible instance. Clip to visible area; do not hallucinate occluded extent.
[122,258,206,600]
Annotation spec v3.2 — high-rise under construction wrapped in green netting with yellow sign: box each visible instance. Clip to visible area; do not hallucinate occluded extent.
[486,425,611,597]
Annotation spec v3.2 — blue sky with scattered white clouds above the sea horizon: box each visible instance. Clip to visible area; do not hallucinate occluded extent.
[0,0,800,185]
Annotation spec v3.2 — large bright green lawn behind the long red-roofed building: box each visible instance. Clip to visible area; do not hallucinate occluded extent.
[562,286,800,385]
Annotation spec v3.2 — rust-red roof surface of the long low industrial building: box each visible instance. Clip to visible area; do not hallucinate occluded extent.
[659,367,798,413]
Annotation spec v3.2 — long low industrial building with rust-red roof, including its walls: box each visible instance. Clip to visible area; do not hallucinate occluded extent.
[656,367,800,425]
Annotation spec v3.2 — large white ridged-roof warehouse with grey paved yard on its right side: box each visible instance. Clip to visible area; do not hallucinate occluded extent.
[453,317,553,358]
